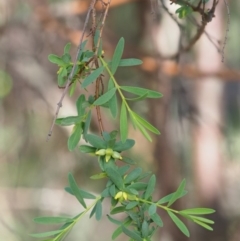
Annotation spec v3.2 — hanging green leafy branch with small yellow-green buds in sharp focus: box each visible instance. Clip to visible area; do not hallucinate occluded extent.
[31,35,214,241]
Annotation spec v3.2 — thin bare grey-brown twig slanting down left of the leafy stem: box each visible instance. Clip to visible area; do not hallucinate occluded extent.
[47,0,96,141]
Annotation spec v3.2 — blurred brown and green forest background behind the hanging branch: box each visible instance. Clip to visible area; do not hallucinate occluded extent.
[0,0,240,241]
